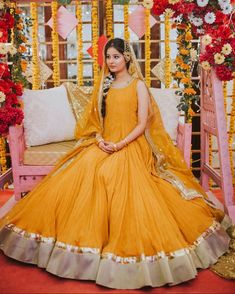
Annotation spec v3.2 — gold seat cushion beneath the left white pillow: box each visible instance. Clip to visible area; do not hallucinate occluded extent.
[24,140,76,165]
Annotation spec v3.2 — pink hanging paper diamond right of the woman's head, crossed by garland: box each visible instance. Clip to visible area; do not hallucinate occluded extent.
[129,5,157,38]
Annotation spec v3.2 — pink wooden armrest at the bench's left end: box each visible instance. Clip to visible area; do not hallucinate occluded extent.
[8,125,26,168]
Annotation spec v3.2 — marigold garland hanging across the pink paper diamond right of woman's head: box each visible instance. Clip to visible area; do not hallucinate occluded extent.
[145,8,151,87]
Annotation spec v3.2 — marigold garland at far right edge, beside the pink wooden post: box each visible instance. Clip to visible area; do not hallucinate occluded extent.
[228,78,235,184]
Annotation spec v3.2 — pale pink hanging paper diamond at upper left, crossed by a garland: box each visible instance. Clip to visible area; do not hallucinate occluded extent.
[47,6,78,39]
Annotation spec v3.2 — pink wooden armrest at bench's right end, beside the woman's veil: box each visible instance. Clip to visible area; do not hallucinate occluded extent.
[176,122,192,168]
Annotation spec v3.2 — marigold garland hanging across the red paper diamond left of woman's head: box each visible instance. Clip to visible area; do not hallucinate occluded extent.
[91,0,99,86]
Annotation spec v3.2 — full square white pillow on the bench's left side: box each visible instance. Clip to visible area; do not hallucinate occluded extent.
[22,85,76,146]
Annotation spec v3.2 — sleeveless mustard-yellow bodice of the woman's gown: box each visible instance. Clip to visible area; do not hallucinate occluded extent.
[103,79,138,142]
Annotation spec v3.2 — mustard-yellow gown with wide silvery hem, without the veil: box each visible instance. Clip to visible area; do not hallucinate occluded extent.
[0,79,229,289]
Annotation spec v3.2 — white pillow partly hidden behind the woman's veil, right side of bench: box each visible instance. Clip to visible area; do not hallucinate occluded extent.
[150,88,180,142]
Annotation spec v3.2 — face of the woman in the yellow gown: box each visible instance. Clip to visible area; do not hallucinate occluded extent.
[106,47,126,73]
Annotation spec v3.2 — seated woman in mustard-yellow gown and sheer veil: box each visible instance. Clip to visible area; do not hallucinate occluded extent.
[0,39,229,289]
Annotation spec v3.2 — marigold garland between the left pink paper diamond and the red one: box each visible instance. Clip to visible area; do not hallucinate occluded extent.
[76,0,84,86]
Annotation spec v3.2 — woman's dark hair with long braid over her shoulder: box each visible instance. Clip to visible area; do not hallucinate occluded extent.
[101,38,130,117]
